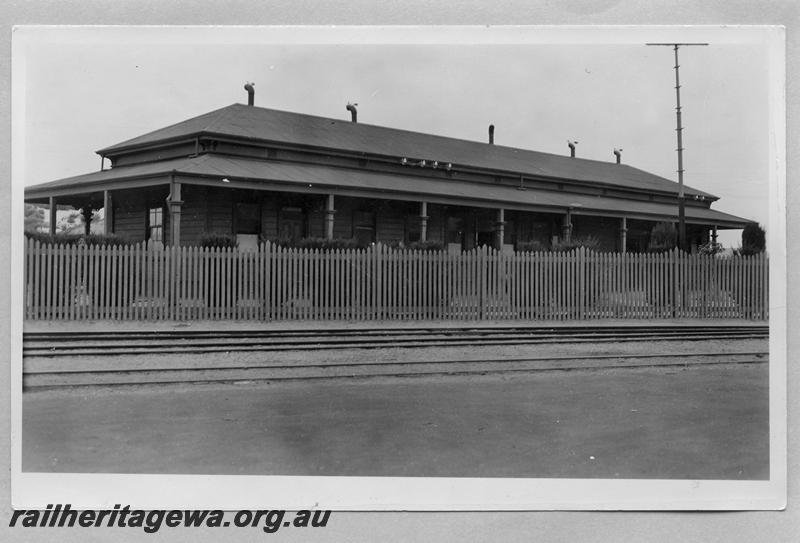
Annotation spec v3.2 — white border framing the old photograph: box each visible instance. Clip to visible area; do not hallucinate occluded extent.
[10,26,787,511]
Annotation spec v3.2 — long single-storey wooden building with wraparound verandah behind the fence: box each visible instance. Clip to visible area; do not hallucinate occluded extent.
[25,86,750,251]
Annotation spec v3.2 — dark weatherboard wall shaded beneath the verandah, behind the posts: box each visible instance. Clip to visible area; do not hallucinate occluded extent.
[101,183,708,252]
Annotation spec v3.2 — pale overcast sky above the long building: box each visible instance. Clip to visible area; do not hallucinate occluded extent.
[13,27,771,246]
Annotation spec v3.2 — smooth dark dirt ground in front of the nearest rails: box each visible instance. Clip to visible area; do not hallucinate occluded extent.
[22,362,769,479]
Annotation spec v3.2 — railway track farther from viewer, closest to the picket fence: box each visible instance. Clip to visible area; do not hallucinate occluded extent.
[23,325,769,358]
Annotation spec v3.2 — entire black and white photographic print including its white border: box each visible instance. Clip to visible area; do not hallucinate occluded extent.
[11,26,786,510]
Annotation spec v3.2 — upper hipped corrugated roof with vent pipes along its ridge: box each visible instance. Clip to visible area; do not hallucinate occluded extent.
[98,104,716,199]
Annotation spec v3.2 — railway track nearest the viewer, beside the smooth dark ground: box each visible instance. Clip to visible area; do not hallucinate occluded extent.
[23,351,769,390]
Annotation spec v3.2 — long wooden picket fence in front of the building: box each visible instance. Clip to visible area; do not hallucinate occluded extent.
[25,240,768,321]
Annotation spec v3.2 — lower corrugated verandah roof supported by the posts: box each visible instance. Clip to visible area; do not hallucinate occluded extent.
[26,155,751,227]
